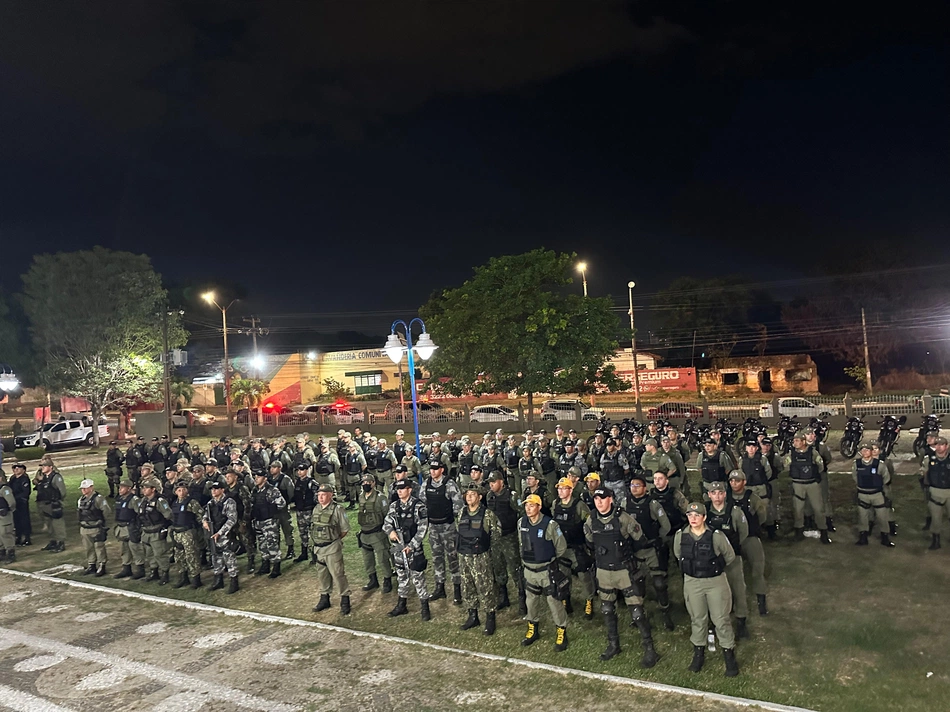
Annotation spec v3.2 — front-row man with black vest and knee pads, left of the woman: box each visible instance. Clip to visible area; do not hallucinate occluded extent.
[584,487,659,668]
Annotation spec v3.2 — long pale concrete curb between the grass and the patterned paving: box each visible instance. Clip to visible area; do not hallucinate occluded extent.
[0,568,811,712]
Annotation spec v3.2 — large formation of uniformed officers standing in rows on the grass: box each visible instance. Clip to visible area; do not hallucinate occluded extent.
[0,423,950,676]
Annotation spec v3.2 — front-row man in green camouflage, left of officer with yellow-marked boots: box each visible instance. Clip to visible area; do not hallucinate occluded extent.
[455,482,501,635]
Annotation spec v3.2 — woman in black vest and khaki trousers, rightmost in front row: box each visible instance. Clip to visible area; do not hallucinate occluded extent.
[673,502,739,677]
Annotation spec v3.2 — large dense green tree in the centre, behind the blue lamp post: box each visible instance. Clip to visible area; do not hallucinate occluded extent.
[420,249,630,409]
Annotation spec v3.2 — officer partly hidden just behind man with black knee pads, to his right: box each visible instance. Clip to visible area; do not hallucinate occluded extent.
[624,470,675,630]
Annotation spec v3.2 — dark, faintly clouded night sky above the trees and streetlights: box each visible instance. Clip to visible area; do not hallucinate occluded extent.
[0,0,950,354]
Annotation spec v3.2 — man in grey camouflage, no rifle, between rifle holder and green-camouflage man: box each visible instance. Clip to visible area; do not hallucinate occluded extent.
[423,459,462,606]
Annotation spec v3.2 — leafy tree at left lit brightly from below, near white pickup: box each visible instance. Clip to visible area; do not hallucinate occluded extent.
[22,247,187,445]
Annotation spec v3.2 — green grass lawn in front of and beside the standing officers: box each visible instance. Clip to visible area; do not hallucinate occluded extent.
[3,454,950,712]
